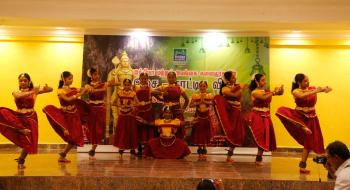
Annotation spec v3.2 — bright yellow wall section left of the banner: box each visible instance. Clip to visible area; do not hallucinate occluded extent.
[0,37,83,144]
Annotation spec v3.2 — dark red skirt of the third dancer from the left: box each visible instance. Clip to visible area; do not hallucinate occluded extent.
[85,104,106,144]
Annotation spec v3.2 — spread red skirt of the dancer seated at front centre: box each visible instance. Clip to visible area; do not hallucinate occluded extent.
[144,137,191,159]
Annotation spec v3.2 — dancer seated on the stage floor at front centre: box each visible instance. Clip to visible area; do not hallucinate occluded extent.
[136,106,191,159]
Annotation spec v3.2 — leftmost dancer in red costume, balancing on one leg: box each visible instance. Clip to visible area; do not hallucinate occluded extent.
[0,73,52,169]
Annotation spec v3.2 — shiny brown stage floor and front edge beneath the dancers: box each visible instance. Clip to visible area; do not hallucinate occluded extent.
[0,147,334,190]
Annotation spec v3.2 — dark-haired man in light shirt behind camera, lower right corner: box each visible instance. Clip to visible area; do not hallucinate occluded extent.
[325,141,350,190]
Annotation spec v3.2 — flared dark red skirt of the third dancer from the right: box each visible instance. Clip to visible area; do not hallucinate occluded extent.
[214,96,246,146]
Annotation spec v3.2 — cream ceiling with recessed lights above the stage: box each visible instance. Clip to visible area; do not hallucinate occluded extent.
[0,0,350,39]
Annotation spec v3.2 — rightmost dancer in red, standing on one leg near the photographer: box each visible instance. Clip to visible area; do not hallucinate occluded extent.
[276,73,332,174]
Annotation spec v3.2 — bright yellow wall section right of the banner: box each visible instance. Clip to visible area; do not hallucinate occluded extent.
[270,41,350,147]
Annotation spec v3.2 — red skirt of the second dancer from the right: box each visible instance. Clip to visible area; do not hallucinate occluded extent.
[248,111,276,151]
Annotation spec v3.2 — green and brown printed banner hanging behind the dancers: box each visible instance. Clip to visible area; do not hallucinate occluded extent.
[82,35,269,95]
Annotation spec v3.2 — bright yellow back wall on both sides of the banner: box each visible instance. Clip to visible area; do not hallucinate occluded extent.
[0,37,350,147]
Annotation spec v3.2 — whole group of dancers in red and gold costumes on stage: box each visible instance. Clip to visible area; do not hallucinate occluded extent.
[0,68,332,173]
